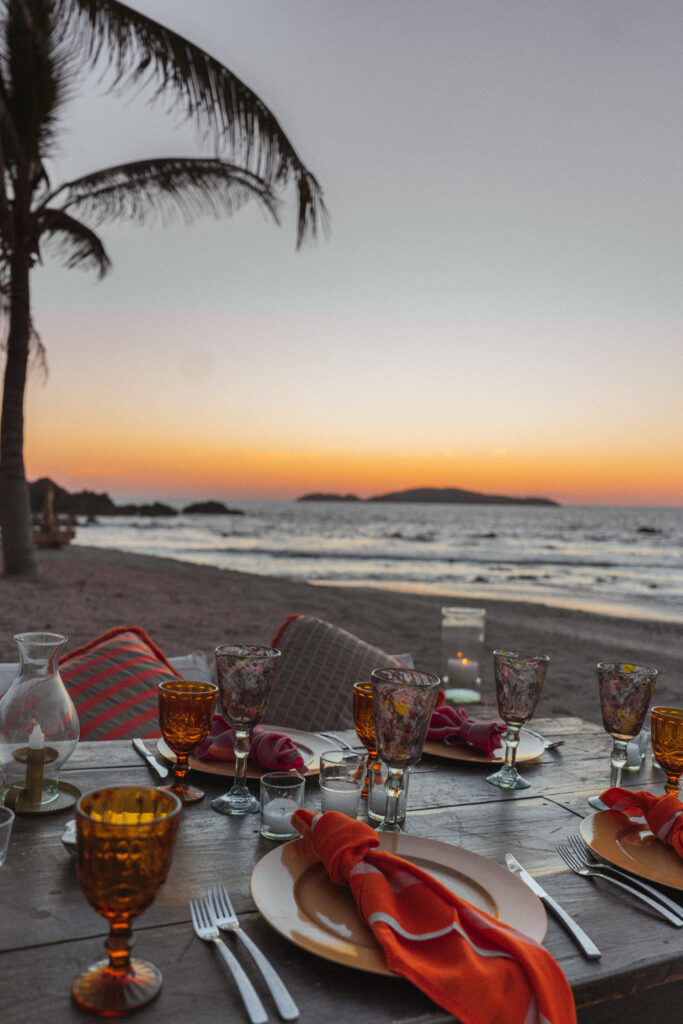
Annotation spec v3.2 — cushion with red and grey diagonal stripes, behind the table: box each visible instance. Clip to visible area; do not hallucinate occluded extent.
[59,626,181,739]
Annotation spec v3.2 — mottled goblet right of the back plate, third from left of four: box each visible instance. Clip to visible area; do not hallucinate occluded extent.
[486,650,550,790]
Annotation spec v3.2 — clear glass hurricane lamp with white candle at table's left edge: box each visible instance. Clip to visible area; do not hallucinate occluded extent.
[0,633,80,814]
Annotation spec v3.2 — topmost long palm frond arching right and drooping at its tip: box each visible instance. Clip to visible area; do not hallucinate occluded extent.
[52,0,328,247]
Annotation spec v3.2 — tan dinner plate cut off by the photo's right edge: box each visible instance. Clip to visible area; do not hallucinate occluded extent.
[579,811,683,891]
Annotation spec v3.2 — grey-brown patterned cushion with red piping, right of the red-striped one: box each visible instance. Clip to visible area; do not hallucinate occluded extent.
[263,615,401,731]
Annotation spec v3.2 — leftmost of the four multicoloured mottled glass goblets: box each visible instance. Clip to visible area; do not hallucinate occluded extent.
[211,644,281,814]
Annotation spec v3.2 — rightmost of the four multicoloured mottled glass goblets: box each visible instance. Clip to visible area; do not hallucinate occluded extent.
[589,662,657,810]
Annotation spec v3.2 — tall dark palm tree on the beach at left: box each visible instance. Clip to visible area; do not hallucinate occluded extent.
[0,0,326,573]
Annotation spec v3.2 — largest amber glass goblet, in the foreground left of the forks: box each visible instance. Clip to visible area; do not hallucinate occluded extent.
[72,785,182,1017]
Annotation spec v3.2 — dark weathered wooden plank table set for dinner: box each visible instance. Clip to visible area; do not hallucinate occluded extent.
[0,718,683,1024]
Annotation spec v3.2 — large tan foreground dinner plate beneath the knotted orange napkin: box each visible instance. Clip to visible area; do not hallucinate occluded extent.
[251,833,548,974]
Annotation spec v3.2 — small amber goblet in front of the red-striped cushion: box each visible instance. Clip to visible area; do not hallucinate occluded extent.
[158,679,218,804]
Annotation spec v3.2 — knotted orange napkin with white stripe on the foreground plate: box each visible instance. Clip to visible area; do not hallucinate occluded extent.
[292,810,577,1024]
